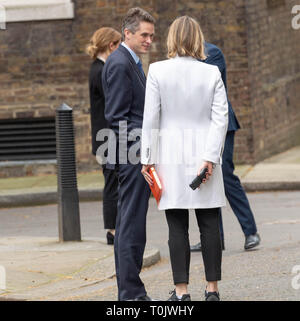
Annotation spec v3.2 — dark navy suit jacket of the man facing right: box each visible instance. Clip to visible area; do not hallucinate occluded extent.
[102,45,146,168]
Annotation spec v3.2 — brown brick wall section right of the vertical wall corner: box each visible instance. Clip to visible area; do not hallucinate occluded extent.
[245,0,300,161]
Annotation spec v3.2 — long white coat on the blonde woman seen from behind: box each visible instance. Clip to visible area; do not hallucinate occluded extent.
[141,56,228,210]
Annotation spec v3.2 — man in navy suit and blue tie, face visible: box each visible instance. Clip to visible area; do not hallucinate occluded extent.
[102,8,155,301]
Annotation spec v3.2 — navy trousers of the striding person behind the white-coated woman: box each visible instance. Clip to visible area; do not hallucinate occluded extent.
[220,131,257,239]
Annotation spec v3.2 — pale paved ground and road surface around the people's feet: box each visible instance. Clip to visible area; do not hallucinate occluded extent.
[0,146,300,301]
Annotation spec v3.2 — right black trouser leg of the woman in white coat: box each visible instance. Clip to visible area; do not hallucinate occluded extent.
[195,208,222,281]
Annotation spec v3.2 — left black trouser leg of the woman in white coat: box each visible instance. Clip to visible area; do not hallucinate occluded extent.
[165,209,190,284]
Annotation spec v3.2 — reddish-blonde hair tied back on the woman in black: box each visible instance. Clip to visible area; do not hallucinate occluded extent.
[85,27,121,59]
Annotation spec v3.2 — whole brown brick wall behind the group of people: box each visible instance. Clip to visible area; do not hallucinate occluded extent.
[0,0,300,175]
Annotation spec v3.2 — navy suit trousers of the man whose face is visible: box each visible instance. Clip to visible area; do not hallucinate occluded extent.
[114,164,150,301]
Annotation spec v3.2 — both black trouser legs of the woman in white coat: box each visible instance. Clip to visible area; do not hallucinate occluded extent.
[165,208,222,284]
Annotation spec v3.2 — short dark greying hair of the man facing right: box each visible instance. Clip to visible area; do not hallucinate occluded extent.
[122,7,155,40]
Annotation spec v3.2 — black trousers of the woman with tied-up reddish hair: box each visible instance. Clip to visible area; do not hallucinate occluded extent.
[102,165,118,230]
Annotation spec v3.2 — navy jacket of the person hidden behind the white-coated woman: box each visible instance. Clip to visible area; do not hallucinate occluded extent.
[204,42,240,131]
